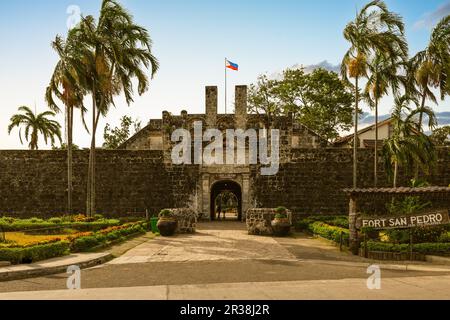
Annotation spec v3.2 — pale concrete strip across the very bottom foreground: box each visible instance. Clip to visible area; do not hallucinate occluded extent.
[0,276,450,300]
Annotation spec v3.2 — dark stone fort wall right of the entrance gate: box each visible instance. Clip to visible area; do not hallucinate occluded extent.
[251,148,450,215]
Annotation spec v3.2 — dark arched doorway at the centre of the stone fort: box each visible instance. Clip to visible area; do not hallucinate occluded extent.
[210,180,242,221]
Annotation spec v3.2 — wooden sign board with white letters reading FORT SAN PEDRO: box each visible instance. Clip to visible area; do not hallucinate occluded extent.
[356,210,450,230]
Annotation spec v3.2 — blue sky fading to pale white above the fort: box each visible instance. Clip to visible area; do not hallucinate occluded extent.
[0,0,450,149]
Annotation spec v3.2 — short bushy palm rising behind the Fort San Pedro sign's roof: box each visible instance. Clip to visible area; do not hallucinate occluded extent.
[383,95,436,188]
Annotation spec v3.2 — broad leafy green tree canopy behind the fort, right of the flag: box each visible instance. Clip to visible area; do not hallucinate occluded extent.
[248,69,354,142]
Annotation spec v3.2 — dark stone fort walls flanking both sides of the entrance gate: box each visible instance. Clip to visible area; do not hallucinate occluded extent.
[0,148,450,217]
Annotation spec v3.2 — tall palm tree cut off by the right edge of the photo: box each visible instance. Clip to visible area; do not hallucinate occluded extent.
[411,16,450,131]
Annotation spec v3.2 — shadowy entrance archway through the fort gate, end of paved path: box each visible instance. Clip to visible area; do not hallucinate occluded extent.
[210,180,242,221]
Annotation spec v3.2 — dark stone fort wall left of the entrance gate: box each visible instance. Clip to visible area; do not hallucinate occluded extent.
[0,150,198,217]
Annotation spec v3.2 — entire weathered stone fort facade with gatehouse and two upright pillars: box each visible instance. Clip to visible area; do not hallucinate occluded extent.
[0,86,450,220]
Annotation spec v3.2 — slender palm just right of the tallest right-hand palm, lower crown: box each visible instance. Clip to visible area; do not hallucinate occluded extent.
[364,50,407,187]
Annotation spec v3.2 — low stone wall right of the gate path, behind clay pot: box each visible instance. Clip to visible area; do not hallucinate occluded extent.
[247,208,292,236]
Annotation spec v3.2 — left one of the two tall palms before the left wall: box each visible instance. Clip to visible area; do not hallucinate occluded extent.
[45,30,86,215]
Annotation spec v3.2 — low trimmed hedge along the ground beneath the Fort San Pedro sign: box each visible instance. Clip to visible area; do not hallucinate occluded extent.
[367,241,450,255]
